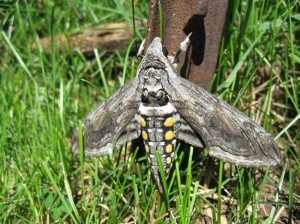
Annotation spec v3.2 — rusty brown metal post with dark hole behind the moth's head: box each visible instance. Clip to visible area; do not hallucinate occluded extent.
[146,0,228,89]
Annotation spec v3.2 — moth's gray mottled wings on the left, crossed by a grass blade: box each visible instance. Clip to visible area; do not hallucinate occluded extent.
[72,78,141,156]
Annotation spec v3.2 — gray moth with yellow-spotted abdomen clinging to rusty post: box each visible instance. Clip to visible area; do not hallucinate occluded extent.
[72,37,280,192]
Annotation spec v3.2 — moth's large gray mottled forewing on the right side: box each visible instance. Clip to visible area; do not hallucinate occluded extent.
[164,71,280,166]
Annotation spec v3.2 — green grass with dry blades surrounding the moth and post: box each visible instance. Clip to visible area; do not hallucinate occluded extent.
[0,0,300,223]
